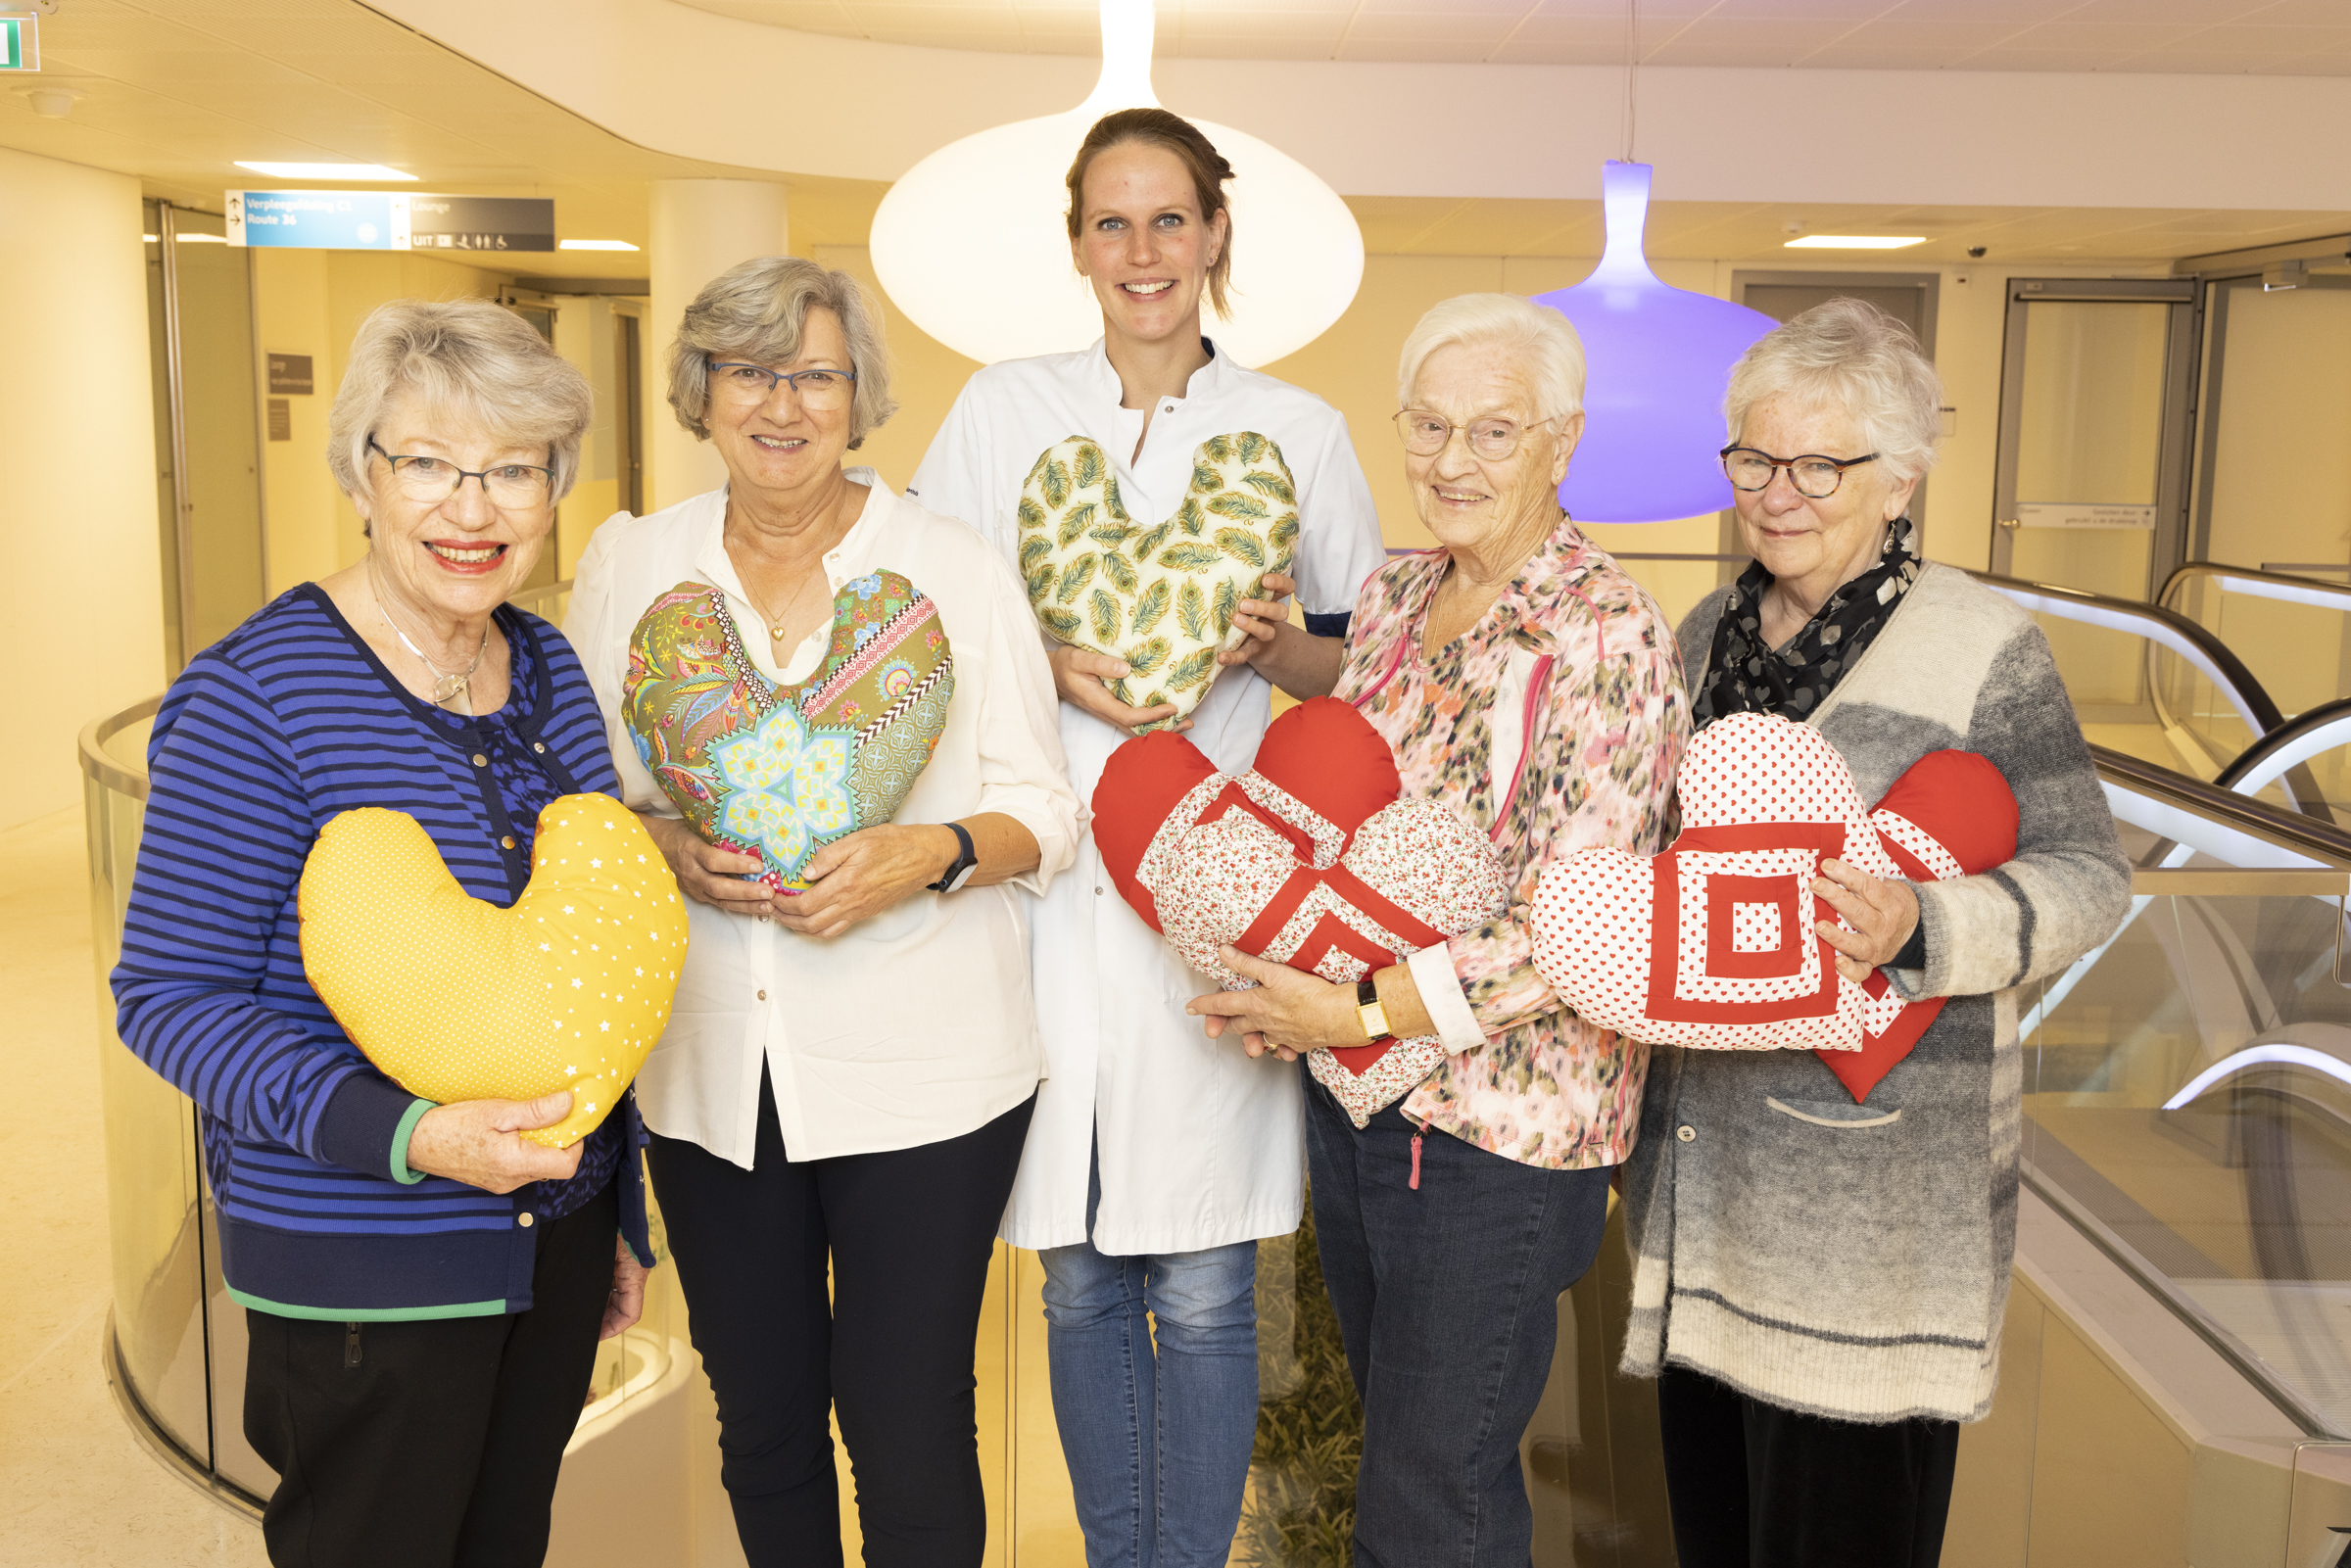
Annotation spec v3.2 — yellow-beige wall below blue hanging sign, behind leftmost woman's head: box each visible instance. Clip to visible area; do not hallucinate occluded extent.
[254,249,505,597]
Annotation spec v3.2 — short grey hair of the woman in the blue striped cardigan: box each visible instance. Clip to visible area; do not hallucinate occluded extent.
[327,299,595,500]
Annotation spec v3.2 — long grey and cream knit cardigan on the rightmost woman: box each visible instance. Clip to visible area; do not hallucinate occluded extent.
[1624,564,2130,1422]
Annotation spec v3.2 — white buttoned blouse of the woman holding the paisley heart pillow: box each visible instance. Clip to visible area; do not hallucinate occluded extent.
[564,468,1083,1168]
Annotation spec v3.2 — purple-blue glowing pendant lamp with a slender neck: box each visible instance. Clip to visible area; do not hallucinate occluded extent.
[1535,163,1780,522]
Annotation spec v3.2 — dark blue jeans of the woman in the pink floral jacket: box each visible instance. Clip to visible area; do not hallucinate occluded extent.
[1300,1063,1608,1568]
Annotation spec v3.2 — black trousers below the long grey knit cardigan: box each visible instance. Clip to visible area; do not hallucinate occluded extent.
[1657,1366,1958,1568]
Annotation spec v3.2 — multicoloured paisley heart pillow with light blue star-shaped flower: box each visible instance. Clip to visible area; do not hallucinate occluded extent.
[621,571,954,893]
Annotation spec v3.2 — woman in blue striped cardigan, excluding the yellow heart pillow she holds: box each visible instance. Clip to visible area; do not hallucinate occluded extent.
[113,301,651,1568]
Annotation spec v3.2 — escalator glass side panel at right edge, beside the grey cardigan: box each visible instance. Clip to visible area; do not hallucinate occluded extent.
[2022,752,2351,1437]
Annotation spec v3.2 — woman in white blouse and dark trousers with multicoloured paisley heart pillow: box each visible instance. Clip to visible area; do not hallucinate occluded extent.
[566,257,1081,1568]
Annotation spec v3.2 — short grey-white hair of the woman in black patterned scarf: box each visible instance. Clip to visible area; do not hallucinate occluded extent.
[1723,299,1942,482]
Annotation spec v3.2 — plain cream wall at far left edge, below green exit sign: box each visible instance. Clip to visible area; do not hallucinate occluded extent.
[0,151,165,828]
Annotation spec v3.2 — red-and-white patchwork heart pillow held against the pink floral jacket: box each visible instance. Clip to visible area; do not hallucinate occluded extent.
[1093,698,1510,1126]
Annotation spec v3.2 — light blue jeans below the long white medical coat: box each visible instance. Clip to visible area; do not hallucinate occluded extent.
[1039,1152,1258,1568]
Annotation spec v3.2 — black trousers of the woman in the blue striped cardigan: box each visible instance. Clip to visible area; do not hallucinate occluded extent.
[245,1182,621,1568]
